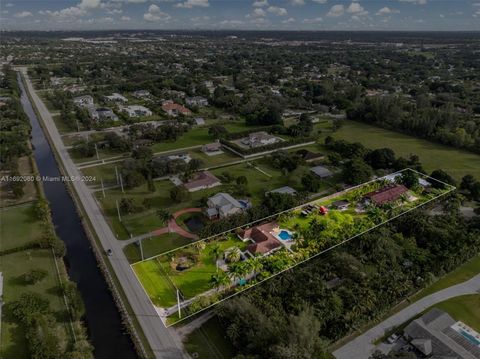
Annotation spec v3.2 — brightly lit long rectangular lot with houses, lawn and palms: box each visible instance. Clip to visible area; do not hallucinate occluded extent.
[132,169,455,326]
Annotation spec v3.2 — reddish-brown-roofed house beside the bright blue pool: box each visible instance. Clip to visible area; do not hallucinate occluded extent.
[239,221,283,256]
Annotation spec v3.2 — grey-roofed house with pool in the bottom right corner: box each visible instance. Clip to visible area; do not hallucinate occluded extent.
[404,308,480,359]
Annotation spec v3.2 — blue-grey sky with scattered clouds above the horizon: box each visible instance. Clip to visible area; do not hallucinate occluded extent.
[0,0,480,31]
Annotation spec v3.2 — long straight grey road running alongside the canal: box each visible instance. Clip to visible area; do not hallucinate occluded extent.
[20,68,188,359]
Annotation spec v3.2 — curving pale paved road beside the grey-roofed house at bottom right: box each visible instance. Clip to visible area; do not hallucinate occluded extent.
[333,274,480,359]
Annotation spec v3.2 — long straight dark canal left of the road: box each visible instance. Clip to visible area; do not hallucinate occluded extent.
[18,75,137,359]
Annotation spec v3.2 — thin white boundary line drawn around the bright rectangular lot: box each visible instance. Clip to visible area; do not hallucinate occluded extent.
[130,168,456,328]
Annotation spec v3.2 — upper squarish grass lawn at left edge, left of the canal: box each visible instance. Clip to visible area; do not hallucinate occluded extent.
[0,203,42,250]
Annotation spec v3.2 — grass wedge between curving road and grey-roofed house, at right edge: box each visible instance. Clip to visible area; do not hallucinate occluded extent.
[434,294,480,332]
